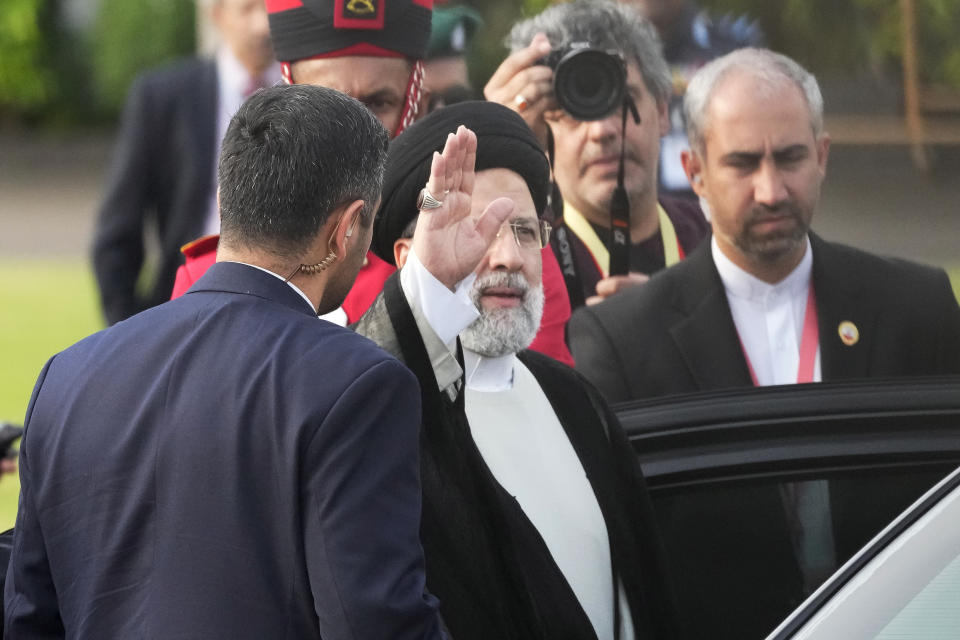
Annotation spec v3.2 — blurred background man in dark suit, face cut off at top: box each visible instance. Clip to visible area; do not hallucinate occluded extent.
[92,0,280,324]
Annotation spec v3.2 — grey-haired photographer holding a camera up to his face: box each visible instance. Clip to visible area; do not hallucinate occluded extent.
[484,0,709,307]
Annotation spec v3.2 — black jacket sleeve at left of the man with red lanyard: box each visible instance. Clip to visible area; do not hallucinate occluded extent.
[567,307,630,404]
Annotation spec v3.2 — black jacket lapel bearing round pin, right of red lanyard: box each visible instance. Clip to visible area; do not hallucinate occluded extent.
[810,233,879,381]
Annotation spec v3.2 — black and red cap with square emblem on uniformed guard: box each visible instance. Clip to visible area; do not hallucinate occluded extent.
[266,0,433,62]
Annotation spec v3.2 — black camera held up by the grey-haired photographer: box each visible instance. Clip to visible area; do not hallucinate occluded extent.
[540,42,627,120]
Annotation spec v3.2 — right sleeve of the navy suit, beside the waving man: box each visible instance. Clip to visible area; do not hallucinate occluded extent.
[303,359,443,640]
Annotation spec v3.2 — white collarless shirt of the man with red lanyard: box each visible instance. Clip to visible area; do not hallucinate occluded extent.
[711,237,821,385]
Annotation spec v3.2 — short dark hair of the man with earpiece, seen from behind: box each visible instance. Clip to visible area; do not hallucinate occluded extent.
[218,85,388,259]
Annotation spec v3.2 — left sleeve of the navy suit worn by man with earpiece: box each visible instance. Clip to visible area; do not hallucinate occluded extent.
[3,359,64,640]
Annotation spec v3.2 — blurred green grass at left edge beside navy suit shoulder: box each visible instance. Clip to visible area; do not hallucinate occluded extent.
[0,259,103,531]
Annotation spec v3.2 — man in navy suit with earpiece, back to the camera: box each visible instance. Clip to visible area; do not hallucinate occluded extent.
[4,85,443,640]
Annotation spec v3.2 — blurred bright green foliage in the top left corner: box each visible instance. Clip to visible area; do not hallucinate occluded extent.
[0,0,55,118]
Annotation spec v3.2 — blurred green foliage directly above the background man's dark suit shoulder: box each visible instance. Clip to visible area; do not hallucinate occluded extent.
[91,0,196,112]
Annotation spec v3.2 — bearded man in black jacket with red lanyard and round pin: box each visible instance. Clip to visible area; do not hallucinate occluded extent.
[569,49,960,402]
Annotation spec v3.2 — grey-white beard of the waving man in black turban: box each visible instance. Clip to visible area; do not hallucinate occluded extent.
[460,272,544,358]
